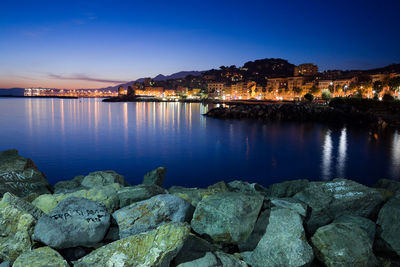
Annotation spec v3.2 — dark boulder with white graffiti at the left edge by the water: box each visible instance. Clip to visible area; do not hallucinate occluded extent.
[0,149,52,196]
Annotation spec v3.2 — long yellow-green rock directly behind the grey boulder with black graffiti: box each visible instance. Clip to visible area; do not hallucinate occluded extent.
[32,183,121,213]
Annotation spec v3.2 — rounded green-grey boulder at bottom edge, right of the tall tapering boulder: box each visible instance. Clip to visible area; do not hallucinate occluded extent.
[311,223,377,267]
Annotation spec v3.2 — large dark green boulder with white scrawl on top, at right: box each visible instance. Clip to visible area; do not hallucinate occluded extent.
[294,179,383,234]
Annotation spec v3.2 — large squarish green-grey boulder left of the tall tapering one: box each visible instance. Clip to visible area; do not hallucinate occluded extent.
[191,192,263,244]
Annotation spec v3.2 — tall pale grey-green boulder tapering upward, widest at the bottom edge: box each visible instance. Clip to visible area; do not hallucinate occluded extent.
[245,208,314,267]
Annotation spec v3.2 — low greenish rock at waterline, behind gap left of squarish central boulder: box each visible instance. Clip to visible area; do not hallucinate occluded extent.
[168,182,230,207]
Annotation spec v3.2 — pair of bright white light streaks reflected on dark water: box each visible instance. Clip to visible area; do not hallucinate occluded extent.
[321,128,347,180]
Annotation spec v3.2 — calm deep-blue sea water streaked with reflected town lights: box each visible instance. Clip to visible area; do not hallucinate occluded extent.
[0,98,400,187]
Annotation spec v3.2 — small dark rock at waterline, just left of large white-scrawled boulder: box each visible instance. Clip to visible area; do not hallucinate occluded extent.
[266,179,309,198]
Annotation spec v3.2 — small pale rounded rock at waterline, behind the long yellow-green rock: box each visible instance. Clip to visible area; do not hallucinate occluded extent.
[81,171,128,188]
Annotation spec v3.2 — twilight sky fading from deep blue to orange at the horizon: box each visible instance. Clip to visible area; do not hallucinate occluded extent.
[0,0,400,88]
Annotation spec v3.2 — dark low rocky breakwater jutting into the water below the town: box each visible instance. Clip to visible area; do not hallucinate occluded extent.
[205,103,383,127]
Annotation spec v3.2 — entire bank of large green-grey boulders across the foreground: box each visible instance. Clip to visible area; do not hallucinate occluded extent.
[0,150,400,267]
